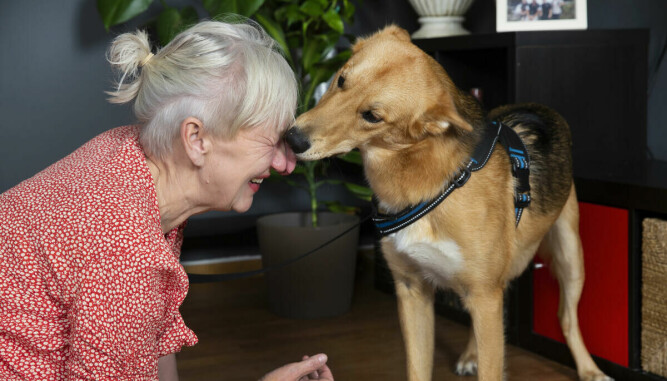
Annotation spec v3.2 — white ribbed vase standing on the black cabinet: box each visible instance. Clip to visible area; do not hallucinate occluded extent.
[409,0,474,38]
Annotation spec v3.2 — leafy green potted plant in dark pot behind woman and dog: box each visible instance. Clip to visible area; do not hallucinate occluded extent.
[97,0,371,318]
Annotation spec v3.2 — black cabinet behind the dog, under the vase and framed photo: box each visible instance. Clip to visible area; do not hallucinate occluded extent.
[414,30,648,180]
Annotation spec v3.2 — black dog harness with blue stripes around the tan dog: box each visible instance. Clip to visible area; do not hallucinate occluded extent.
[373,121,530,236]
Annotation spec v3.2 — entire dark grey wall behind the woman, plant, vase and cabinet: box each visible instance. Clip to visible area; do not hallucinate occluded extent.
[0,0,667,214]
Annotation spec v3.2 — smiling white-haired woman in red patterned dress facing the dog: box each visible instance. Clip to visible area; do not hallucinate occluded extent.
[0,21,333,381]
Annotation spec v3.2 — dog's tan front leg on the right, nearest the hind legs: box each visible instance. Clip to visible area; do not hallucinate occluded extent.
[464,287,505,381]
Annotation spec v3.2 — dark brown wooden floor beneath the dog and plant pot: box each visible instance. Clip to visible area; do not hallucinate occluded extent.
[177,253,576,381]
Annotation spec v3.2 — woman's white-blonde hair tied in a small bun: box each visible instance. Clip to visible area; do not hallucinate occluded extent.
[107,20,298,156]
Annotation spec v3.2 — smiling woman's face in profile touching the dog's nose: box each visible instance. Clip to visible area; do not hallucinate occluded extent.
[202,128,296,213]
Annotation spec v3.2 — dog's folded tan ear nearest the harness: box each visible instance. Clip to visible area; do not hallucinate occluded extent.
[408,104,472,138]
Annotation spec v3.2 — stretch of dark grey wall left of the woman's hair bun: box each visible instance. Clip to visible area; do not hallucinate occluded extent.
[0,0,130,192]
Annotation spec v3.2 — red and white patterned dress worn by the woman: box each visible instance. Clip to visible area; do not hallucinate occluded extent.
[0,126,197,380]
